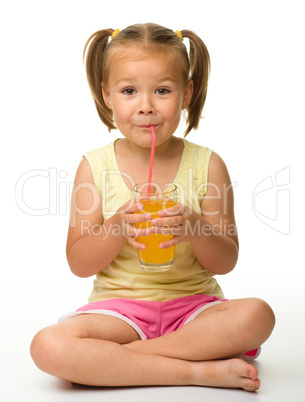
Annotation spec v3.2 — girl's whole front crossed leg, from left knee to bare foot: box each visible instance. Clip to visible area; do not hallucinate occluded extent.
[31,314,259,391]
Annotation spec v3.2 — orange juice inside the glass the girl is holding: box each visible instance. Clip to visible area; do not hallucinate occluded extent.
[135,198,176,271]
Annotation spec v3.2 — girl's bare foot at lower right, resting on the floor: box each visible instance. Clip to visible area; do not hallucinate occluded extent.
[196,359,260,392]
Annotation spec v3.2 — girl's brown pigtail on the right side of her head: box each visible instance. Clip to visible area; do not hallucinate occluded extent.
[181,30,210,136]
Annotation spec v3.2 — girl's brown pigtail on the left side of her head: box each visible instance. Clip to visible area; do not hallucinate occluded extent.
[83,28,116,131]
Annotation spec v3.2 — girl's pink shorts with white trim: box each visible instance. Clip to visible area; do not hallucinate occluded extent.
[59,294,226,339]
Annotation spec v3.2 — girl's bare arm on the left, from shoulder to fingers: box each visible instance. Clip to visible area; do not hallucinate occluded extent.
[66,158,147,277]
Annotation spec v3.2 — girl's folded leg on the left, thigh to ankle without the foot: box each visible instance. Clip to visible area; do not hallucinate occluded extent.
[31,314,191,386]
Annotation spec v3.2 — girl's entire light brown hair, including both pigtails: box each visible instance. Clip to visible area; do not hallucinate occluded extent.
[84,23,210,136]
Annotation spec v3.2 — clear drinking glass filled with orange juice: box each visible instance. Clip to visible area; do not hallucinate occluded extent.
[132,182,177,272]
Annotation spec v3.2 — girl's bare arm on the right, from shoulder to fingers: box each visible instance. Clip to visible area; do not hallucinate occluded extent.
[152,153,238,274]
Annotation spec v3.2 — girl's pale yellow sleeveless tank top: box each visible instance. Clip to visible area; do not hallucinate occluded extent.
[85,140,224,303]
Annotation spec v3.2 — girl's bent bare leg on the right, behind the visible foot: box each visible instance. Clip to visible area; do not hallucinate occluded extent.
[125,298,275,361]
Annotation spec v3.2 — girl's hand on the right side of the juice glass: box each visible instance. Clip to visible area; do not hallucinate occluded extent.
[151,203,204,248]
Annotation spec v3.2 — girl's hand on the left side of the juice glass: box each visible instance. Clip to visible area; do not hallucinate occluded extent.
[116,200,153,250]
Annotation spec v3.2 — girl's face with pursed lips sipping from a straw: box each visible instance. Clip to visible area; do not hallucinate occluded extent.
[102,47,193,148]
